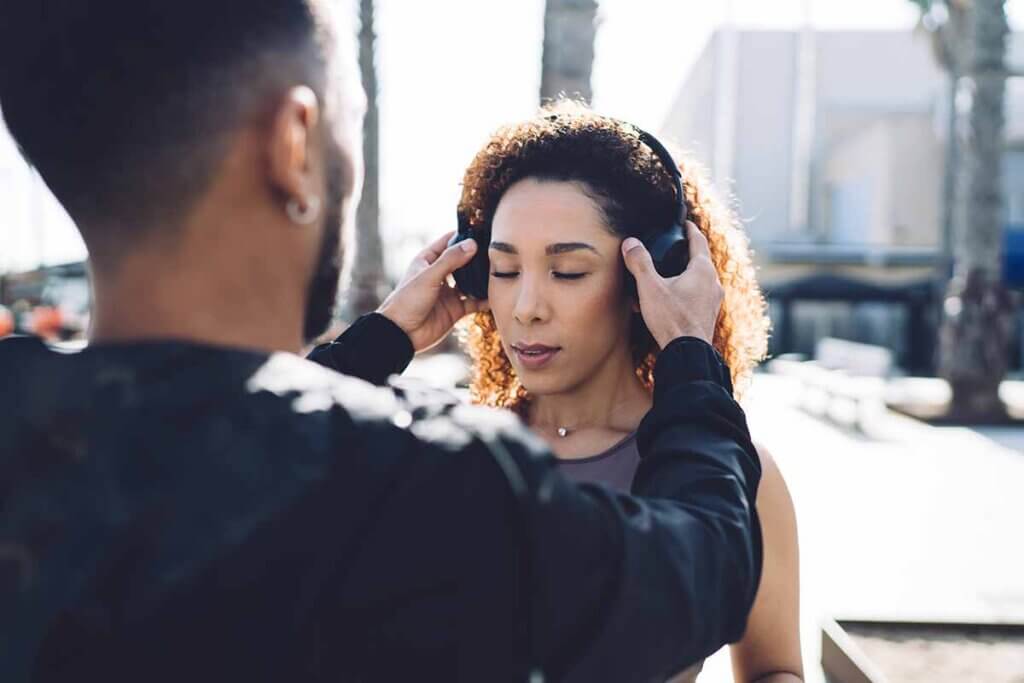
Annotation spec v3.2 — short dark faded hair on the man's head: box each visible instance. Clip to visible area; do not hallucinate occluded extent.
[0,0,330,241]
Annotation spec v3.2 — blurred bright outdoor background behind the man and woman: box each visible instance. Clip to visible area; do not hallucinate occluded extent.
[6,0,1024,683]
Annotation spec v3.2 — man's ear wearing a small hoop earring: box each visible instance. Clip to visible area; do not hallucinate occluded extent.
[268,85,321,208]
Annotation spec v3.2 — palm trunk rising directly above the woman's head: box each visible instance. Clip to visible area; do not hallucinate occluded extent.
[541,0,597,103]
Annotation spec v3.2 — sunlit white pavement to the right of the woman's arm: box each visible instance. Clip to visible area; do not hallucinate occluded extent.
[700,375,1024,683]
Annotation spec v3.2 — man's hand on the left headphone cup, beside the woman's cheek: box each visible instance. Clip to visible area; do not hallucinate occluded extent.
[377,232,487,353]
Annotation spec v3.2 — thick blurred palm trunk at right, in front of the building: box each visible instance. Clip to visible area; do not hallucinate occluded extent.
[913,0,1013,422]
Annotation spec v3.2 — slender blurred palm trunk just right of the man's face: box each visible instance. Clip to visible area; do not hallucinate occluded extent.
[342,0,387,321]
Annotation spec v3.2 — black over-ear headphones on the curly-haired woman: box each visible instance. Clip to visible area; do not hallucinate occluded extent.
[449,122,690,299]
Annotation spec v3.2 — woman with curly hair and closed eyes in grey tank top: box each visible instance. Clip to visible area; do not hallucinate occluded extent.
[459,101,803,683]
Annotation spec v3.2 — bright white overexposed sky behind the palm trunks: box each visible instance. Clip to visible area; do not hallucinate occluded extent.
[0,0,1024,273]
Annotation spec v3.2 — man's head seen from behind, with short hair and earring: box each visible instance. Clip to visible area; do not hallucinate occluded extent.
[0,0,365,337]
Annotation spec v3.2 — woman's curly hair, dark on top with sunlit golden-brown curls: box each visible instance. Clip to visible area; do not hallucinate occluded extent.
[459,99,770,415]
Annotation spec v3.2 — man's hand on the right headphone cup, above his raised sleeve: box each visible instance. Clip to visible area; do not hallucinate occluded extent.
[623,221,725,348]
